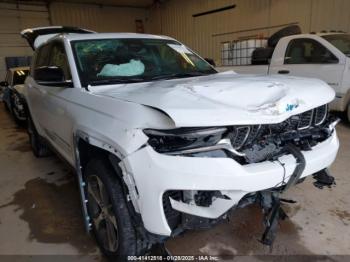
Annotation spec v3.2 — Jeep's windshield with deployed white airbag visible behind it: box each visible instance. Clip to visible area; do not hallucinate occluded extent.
[72,39,216,86]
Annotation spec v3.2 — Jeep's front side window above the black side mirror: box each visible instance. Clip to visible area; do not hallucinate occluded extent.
[49,42,72,80]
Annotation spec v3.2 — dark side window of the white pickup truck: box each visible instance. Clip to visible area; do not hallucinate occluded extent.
[284,39,338,64]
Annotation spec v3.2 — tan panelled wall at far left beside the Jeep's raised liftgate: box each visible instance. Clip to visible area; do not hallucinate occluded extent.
[0,2,49,79]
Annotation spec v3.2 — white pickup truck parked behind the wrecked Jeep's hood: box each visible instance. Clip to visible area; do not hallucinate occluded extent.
[217,32,350,121]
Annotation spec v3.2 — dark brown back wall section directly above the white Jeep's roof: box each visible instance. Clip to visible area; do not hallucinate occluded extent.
[50,2,146,32]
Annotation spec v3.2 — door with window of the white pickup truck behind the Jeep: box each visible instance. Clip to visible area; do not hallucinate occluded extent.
[270,38,345,89]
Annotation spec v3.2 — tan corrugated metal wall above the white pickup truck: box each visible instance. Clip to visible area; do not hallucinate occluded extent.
[148,0,350,63]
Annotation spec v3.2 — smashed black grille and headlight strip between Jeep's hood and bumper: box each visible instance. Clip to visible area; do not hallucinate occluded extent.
[144,105,338,165]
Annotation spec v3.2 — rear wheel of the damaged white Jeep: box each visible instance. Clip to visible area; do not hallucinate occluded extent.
[27,116,51,157]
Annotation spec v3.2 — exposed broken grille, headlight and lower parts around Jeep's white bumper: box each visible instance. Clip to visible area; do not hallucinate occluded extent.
[144,105,339,245]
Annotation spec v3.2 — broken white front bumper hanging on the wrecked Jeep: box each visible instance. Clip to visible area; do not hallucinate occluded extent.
[122,131,339,236]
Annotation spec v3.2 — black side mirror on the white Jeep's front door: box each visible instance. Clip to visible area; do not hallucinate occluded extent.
[34,66,72,87]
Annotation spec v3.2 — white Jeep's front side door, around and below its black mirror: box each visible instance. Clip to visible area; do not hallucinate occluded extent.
[31,40,74,162]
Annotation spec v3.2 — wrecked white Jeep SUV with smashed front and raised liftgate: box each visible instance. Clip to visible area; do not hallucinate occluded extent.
[22,27,339,255]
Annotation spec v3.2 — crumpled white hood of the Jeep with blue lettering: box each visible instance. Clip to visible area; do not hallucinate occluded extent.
[90,72,335,127]
